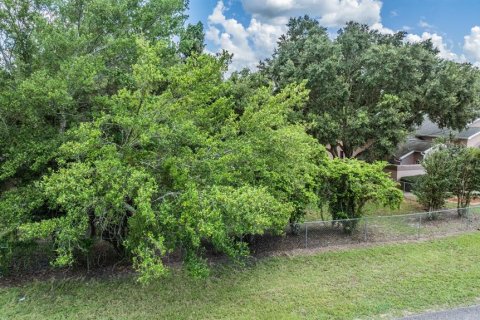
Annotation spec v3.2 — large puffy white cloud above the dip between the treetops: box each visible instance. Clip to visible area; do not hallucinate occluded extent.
[206,0,386,71]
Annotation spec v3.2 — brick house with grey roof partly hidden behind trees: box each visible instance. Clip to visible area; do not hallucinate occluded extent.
[387,118,480,180]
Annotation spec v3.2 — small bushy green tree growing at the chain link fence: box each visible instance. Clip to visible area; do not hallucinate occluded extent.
[320,158,403,233]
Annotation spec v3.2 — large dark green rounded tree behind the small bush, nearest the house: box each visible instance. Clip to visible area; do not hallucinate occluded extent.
[260,16,480,160]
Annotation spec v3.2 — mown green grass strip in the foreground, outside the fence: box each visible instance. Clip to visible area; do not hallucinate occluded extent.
[0,232,480,319]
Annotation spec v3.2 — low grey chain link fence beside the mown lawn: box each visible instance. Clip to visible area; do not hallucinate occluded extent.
[252,205,480,255]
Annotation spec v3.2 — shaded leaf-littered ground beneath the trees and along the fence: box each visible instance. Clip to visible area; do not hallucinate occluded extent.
[0,208,480,286]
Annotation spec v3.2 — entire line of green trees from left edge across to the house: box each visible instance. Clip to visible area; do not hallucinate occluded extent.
[0,0,480,281]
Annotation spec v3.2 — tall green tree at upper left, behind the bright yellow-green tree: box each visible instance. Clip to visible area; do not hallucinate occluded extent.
[0,0,191,192]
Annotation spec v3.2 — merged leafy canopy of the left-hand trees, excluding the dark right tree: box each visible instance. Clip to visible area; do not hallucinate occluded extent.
[0,0,326,280]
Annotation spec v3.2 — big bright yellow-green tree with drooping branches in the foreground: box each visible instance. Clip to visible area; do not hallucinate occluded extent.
[0,39,326,281]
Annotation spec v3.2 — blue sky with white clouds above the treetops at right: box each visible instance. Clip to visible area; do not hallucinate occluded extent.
[189,0,480,71]
